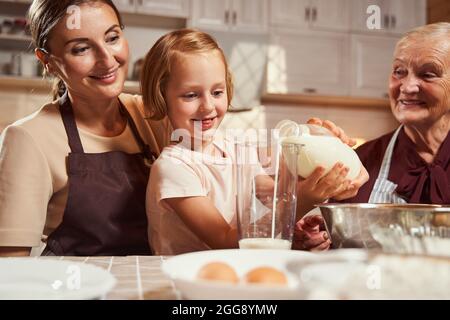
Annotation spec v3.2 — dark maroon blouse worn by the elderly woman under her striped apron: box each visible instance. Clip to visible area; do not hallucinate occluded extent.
[342,129,450,204]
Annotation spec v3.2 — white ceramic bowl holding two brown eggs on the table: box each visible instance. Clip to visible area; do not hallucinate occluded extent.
[163,249,315,300]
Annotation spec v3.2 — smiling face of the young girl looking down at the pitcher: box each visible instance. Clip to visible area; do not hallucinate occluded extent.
[164,51,228,145]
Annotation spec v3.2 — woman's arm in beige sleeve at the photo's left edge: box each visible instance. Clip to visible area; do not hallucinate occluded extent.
[0,125,52,255]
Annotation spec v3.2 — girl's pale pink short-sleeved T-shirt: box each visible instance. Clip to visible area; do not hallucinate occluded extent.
[146,143,236,255]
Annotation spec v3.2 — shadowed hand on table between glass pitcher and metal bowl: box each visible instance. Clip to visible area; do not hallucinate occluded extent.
[292,215,331,251]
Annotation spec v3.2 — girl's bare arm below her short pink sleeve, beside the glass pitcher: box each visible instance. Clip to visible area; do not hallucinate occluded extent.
[161,197,238,249]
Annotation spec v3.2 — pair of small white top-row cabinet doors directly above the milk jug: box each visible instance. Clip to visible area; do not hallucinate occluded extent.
[270,0,350,31]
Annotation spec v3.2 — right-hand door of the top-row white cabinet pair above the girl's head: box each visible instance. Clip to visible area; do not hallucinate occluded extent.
[231,0,268,33]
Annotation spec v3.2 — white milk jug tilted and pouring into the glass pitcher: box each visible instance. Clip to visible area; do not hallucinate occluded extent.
[275,120,361,180]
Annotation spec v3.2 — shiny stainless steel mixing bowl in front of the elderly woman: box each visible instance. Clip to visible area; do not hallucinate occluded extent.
[318,203,450,256]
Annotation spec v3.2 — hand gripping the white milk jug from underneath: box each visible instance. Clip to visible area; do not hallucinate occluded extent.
[297,162,357,216]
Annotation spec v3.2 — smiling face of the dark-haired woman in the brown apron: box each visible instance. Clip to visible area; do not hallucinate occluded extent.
[47,2,129,99]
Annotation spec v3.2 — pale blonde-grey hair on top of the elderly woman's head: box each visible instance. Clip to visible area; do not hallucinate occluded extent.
[395,22,450,51]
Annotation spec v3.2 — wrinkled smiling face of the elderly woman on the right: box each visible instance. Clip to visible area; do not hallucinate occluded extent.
[389,38,450,126]
